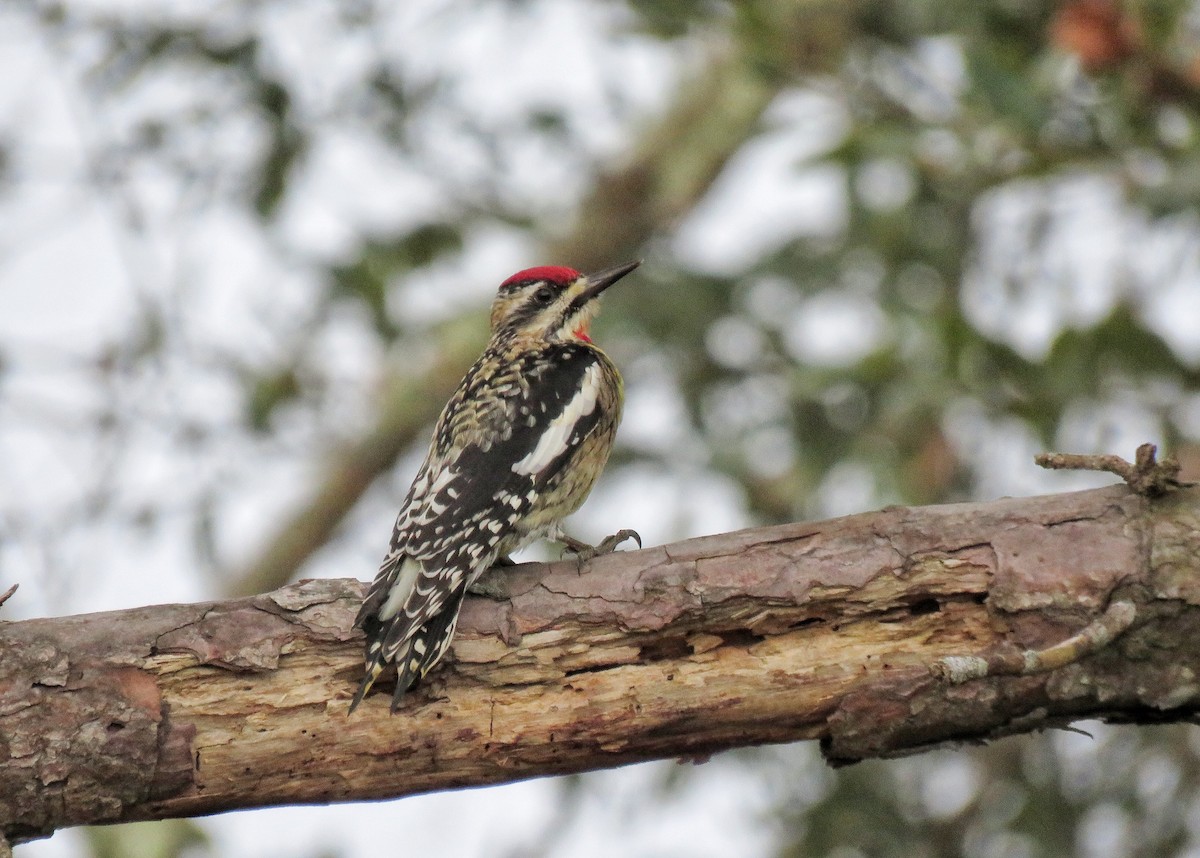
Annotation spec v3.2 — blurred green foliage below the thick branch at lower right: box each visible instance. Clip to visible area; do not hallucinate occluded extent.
[764,725,1200,858]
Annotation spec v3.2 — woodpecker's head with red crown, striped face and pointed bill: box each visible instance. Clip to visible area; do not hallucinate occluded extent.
[492,260,642,342]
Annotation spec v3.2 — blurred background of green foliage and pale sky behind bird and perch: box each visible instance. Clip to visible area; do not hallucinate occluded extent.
[0,0,1200,858]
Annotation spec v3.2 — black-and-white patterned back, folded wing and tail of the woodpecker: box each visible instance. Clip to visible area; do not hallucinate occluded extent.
[358,344,607,710]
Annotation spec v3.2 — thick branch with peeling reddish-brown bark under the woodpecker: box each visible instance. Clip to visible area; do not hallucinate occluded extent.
[0,486,1200,842]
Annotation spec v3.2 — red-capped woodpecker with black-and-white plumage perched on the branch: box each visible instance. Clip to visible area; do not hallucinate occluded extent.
[350,262,641,713]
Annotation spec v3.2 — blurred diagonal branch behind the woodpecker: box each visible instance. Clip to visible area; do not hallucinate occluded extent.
[227,2,850,595]
